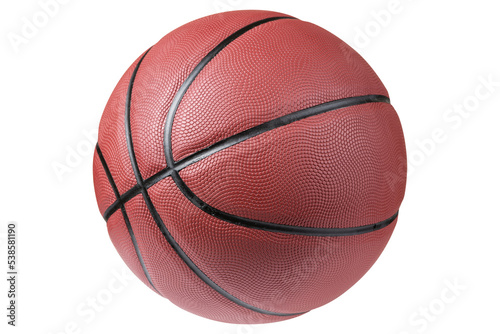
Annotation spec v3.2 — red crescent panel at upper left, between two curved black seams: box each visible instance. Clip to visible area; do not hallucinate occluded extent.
[129,11,292,178]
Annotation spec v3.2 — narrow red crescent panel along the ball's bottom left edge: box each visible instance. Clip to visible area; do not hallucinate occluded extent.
[125,190,300,323]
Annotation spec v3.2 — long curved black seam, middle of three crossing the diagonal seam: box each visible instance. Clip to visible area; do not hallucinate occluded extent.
[125,46,305,316]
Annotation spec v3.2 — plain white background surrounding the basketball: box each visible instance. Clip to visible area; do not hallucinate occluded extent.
[0,0,500,334]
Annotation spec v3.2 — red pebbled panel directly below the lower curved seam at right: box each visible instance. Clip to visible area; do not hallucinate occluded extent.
[149,178,396,313]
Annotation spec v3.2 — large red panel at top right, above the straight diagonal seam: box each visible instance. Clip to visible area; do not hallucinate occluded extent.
[172,20,388,160]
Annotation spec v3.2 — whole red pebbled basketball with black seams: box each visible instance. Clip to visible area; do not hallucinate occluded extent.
[94,11,406,323]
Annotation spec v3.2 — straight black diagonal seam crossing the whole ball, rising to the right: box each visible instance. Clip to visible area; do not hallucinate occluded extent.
[103,95,390,220]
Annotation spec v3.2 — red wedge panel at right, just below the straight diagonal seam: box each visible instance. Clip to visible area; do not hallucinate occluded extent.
[180,103,404,228]
